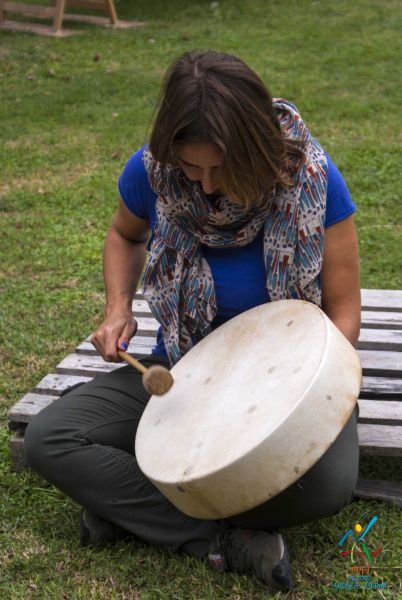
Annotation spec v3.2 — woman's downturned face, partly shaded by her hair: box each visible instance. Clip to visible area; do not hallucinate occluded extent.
[176,142,223,194]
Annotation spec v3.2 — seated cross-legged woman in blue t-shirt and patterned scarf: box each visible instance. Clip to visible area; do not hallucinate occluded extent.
[25,51,360,590]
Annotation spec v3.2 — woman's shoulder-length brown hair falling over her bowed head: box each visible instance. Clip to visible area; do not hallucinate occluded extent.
[149,51,304,208]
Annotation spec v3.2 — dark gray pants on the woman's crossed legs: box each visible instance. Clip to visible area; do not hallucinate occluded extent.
[25,357,359,558]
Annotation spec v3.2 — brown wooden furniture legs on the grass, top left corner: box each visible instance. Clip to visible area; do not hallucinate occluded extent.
[0,0,144,37]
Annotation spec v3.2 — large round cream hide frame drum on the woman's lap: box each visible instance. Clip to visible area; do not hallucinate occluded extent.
[135,300,361,519]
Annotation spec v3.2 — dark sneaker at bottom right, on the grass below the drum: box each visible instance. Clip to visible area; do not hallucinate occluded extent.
[208,529,293,592]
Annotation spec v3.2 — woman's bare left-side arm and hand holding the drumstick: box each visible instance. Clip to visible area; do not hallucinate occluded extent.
[91,200,150,361]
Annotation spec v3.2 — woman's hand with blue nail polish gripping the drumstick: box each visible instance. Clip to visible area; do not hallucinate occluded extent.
[90,312,137,362]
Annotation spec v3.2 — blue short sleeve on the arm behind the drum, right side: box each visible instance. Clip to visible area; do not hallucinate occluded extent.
[325,154,356,227]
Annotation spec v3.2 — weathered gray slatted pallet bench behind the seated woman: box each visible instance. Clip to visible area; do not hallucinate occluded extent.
[8,290,402,507]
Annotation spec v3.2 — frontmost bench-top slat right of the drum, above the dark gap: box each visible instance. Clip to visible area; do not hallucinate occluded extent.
[357,423,402,456]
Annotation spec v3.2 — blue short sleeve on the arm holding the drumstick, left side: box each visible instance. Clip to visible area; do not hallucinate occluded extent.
[119,146,156,228]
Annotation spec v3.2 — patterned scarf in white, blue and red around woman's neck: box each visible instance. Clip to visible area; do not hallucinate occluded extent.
[143,99,327,365]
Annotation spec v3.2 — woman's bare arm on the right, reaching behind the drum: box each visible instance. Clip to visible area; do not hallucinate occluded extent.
[321,216,361,346]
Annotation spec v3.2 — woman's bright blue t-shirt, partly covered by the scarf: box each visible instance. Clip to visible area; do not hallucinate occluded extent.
[119,146,356,355]
